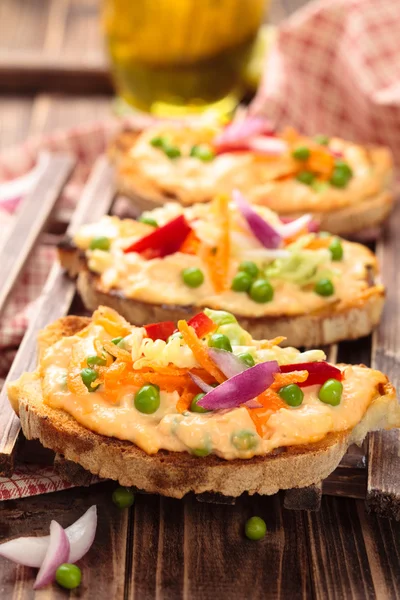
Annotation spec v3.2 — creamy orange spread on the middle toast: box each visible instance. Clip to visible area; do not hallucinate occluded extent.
[74,203,377,317]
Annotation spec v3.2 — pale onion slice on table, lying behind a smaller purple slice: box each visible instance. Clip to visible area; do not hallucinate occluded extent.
[0,505,97,568]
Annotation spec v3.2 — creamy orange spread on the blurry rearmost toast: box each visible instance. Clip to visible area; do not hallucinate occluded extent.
[123,124,392,214]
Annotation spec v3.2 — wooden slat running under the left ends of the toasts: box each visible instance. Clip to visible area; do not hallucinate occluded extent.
[0,157,114,476]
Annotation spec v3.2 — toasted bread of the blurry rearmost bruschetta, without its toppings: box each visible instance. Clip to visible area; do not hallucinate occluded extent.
[109,130,394,236]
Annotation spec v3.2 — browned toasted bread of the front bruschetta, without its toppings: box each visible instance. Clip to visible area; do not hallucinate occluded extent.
[8,317,400,498]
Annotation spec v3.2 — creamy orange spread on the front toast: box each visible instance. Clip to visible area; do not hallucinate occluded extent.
[40,324,386,460]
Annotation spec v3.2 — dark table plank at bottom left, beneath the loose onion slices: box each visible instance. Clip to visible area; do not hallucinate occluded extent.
[0,483,131,600]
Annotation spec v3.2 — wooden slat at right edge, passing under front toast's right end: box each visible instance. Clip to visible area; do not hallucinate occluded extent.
[367,203,400,519]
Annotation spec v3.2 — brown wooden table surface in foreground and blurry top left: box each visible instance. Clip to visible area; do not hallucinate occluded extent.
[0,0,400,600]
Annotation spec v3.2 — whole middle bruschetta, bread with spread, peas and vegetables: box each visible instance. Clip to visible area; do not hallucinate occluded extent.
[59,190,384,347]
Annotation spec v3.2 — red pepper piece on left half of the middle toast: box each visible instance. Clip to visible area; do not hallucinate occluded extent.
[124,215,191,258]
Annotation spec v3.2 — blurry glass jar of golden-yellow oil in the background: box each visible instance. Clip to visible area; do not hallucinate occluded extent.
[103,0,266,116]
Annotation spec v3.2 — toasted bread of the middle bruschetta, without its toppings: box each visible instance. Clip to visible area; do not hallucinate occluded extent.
[59,240,385,348]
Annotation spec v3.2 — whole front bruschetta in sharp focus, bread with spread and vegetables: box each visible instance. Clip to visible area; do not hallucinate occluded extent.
[8,307,400,498]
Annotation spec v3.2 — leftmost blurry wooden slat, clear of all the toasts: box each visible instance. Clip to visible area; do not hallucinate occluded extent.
[0,154,74,311]
